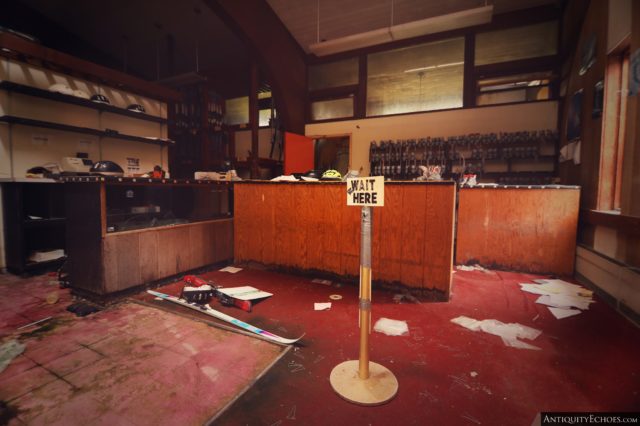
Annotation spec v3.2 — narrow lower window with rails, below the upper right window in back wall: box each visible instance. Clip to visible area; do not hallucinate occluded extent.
[476,71,553,105]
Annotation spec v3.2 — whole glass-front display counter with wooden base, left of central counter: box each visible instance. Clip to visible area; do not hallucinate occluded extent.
[65,177,233,296]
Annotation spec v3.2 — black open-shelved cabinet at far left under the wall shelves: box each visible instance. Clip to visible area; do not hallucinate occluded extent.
[2,179,66,274]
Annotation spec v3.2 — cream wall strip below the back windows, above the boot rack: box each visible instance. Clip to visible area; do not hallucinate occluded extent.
[305,101,558,175]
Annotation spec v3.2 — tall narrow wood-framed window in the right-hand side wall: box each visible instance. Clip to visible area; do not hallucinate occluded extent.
[598,50,629,211]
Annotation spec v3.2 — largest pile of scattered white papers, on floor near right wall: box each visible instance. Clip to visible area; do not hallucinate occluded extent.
[520,280,594,319]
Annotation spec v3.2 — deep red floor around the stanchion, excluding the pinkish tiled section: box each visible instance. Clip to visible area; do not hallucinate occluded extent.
[139,270,640,426]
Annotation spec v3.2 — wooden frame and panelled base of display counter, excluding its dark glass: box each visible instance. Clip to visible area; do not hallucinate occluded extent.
[64,178,233,298]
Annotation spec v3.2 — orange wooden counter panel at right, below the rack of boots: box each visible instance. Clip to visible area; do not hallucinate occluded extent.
[456,188,580,275]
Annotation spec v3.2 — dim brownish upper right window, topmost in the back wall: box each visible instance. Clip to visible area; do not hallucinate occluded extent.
[475,21,558,65]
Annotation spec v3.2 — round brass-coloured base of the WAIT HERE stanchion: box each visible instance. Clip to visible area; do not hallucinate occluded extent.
[329,360,398,405]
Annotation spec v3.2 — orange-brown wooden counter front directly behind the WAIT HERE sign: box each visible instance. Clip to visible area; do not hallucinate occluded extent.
[234,182,455,298]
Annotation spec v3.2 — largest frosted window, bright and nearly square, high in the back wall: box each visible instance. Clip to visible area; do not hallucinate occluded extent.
[367,38,464,116]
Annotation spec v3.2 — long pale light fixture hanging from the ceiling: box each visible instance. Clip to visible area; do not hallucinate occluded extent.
[309,5,493,56]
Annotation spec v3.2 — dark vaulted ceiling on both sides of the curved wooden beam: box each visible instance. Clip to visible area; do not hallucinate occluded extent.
[6,0,560,80]
